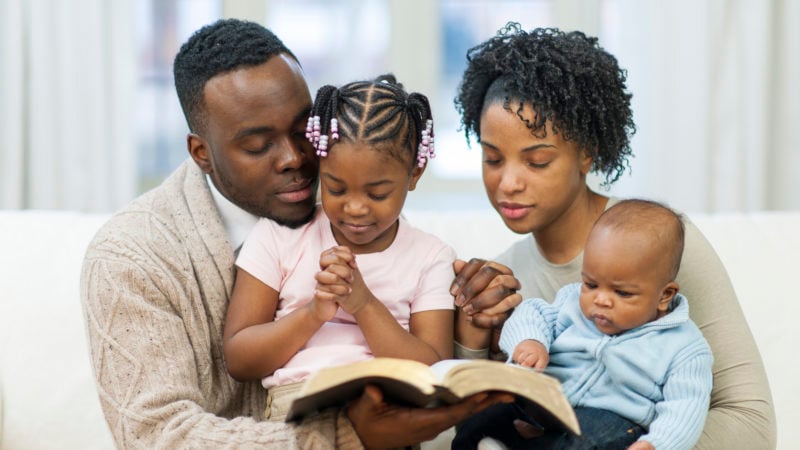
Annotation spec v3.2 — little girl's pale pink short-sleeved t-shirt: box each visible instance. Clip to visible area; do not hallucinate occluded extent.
[236,208,456,388]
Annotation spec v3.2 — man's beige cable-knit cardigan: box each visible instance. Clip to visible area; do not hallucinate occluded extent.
[81,159,363,449]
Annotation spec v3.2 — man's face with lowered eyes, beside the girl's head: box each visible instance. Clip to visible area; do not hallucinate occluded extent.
[189,54,318,226]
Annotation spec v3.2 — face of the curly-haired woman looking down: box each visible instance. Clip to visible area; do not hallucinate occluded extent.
[480,102,592,234]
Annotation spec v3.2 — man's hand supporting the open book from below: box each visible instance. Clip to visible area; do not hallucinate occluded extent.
[347,386,513,449]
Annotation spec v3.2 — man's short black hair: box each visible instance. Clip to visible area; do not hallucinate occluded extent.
[173,19,297,132]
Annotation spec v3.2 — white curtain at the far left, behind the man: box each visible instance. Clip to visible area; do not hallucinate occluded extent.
[0,0,137,212]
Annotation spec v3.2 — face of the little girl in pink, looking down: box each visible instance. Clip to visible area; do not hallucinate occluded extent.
[320,141,422,253]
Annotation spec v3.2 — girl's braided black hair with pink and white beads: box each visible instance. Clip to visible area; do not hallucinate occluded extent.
[307,74,433,170]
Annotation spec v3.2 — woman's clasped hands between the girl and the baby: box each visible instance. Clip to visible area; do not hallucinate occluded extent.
[450,258,522,328]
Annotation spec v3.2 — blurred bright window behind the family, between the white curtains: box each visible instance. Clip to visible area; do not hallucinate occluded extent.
[136,0,553,208]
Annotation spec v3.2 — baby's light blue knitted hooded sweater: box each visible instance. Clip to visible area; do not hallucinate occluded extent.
[500,283,713,450]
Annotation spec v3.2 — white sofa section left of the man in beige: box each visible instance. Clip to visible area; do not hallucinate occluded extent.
[0,211,114,450]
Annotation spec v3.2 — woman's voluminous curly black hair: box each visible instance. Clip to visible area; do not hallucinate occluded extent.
[455,22,636,186]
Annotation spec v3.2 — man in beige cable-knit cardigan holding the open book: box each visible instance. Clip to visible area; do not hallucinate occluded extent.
[81,20,506,448]
